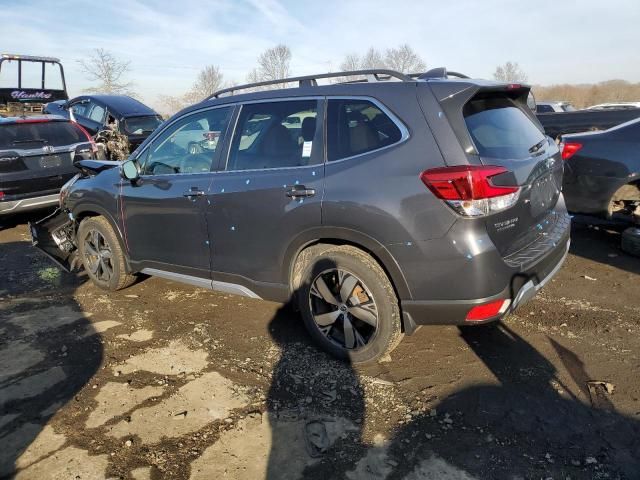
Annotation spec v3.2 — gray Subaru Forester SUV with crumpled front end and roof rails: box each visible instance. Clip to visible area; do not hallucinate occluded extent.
[31,69,570,362]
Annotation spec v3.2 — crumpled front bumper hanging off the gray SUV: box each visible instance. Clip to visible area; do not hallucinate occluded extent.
[29,208,78,272]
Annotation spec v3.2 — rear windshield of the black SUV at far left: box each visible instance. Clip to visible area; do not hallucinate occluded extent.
[0,122,88,150]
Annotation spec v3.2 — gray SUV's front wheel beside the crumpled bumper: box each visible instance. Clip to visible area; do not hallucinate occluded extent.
[76,217,136,291]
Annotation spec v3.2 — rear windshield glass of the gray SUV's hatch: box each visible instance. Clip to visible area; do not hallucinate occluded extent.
[463,97,545,159]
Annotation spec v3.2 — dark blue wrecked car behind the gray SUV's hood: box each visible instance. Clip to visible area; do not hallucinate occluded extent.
[45,95,162,151]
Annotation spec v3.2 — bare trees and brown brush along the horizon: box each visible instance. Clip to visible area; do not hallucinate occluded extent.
[78,48,640,114]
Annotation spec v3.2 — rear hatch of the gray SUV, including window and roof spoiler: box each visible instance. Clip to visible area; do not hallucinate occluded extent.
[422,82,566,257]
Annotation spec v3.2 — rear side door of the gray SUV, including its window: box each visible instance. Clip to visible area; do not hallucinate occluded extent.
[206,99,324,288]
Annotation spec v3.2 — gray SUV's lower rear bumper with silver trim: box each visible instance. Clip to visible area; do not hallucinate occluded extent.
[401,238,570,333]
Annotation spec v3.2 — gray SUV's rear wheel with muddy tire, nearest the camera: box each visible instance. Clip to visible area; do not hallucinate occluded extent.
[294,245,403,364]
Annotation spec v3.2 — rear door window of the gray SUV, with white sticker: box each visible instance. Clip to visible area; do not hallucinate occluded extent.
[226,100,322,170]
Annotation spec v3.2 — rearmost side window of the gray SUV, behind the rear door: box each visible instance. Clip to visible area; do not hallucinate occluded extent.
[327,99,402,161]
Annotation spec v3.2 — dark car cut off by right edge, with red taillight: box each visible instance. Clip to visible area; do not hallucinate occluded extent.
[561,119,640,218]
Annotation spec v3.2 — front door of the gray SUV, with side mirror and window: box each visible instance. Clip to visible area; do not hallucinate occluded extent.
[122,106,234,278]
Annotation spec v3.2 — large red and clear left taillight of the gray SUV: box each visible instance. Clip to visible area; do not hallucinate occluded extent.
[420,165,520,217]
